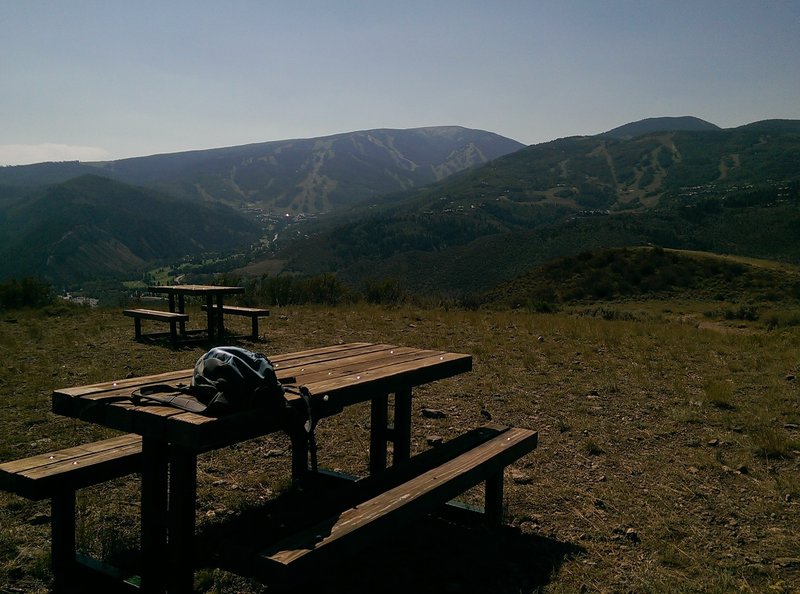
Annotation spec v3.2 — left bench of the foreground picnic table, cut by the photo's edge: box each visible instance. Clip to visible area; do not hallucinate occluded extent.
[0,434,142,589]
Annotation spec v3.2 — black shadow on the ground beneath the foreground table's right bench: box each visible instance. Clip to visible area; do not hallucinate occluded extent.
[202,504,585,594]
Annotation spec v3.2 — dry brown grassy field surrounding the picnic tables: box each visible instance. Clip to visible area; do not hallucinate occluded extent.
[0,302,800,593]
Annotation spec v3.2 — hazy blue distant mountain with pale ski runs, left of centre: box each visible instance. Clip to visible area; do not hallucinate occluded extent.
[0,126,524,214]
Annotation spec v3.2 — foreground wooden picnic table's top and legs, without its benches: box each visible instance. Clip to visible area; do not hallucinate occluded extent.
[53,343,472,592]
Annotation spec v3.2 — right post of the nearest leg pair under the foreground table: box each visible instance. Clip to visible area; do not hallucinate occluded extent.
[169,446,197,593]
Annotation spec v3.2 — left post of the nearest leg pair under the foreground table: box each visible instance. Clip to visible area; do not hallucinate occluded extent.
[141,437,169,594]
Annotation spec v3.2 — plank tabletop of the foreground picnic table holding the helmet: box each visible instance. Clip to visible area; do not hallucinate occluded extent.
[52,343,472,451]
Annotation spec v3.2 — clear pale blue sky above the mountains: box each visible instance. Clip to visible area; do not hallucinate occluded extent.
[0,0,800,165]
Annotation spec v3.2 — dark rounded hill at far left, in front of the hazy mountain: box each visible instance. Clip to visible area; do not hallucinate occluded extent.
[0,175,261,285]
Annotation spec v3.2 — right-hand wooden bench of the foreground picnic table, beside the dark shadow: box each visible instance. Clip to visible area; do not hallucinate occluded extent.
[253,426,537,579]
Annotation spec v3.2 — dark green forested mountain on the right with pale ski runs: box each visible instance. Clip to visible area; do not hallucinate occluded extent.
[281,120,800,294]
